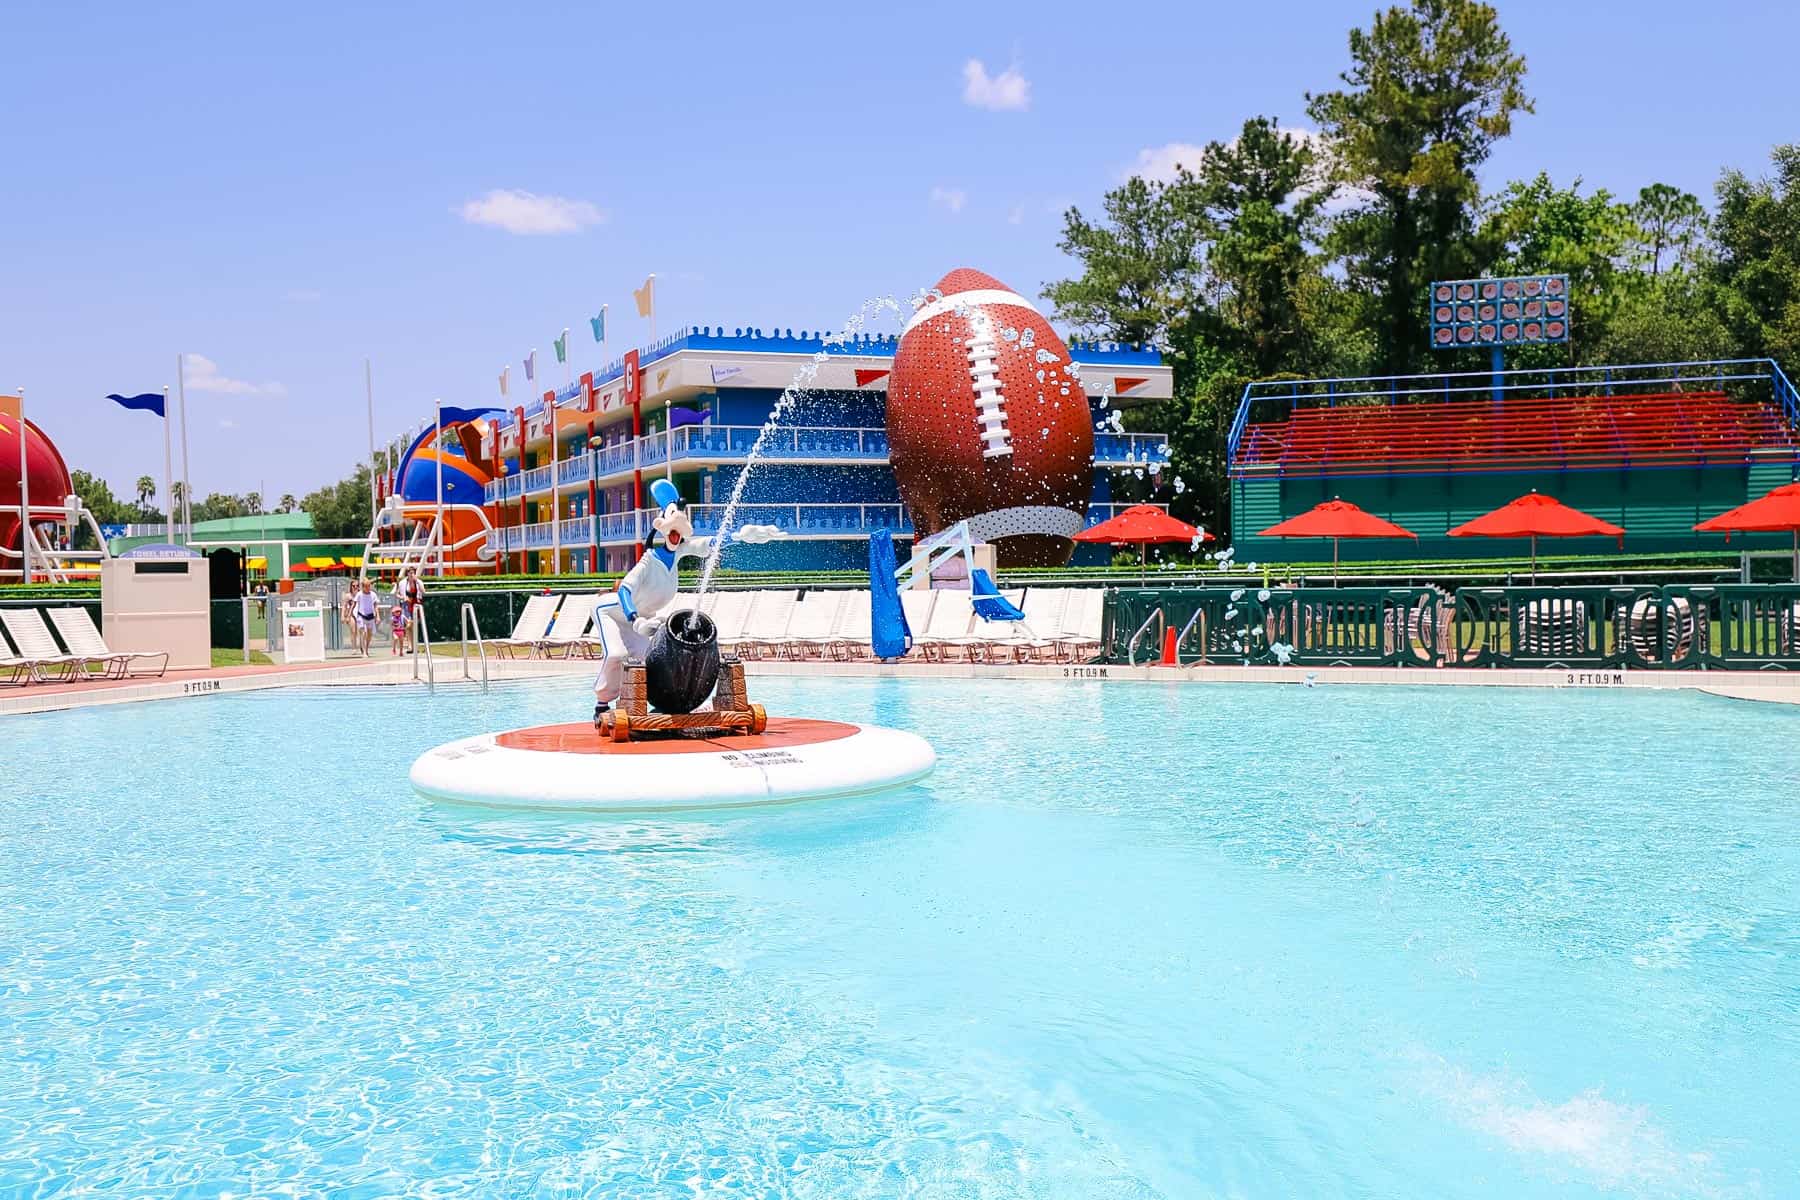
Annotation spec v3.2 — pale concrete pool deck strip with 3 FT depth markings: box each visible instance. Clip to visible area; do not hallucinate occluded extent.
[0,657,1800,716]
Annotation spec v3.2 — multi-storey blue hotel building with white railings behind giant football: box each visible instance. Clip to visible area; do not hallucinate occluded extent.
[457,326,1172,574]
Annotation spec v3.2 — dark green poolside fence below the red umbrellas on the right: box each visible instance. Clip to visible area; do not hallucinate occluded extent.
[1107,585,1800,671]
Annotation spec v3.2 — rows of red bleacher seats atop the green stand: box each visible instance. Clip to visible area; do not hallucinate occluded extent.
[1233,392,1795,475]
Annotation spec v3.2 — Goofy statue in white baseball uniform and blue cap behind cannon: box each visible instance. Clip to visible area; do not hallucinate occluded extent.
[594,479,787,721]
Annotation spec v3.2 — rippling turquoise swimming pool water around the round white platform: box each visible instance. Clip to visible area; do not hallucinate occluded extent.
[0,680,1800,1200]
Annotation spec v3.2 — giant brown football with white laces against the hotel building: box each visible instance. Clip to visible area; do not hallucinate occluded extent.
[887,266,1094,567]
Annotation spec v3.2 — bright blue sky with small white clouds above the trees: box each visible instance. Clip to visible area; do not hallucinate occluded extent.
[0,0,1800,502]
